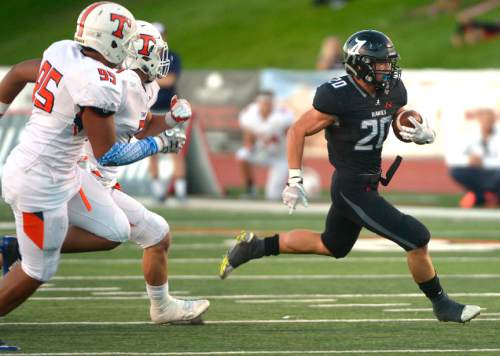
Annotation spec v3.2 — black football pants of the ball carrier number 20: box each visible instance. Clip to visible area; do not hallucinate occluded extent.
[321,173,430,258]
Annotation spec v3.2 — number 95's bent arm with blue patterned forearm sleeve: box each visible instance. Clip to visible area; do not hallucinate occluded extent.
[82,107,185,166]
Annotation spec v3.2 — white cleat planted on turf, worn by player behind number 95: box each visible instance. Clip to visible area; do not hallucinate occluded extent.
[149,298,210,324]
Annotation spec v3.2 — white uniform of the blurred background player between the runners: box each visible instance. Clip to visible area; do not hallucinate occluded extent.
[236,103,293,200]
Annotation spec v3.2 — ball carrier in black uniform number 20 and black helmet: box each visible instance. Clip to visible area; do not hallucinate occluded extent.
[220,30,480,323]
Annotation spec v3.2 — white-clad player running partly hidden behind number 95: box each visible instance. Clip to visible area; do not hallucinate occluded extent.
[78,21,210,324]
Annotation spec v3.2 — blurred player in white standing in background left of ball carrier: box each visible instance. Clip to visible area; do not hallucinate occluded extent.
[236,91,293,200]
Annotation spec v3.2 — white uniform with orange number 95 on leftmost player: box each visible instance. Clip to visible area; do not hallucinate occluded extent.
[2,40,130,281]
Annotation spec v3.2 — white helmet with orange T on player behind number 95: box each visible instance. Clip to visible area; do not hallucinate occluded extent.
[124,20,170,81]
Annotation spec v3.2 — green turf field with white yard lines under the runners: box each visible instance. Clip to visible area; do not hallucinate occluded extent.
[0,204,500,355]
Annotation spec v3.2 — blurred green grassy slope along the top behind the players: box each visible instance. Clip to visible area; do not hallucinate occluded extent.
[0,0,500,69]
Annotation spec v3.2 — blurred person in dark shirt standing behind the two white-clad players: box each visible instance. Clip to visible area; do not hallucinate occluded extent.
[149,22,187,201]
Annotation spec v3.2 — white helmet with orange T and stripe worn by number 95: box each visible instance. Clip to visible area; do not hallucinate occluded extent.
[75,1,136,65]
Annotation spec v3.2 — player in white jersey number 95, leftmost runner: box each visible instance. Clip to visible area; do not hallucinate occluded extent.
[0,2,186,316]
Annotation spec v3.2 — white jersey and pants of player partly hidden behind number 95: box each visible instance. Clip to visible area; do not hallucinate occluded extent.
[75,70,169,248]
